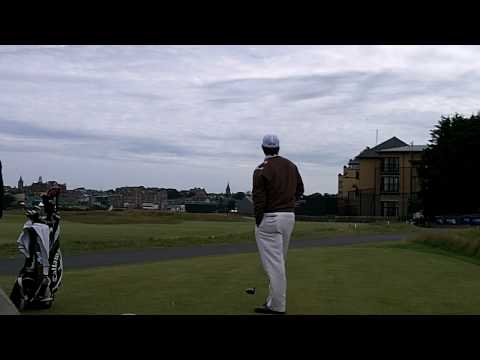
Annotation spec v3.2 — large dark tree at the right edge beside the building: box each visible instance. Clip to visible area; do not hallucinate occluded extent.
[418,113,480,216]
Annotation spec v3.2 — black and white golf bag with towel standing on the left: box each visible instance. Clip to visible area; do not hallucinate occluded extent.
[10,188,63,310]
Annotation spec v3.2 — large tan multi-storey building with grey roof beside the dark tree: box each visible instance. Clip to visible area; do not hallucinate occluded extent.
[338,137,426,219]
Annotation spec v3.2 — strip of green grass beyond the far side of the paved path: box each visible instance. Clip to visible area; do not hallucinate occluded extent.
[0,211,420,257]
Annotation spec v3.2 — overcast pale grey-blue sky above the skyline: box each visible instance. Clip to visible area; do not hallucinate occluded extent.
[0,46,480,194]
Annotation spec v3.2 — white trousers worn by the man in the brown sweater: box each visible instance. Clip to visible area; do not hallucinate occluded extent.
[255,212,295,312]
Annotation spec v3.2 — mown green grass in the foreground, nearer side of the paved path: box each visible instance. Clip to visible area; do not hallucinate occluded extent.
[0,243,480,314]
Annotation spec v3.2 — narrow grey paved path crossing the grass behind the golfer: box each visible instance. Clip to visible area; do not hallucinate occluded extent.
[0,234,405,275]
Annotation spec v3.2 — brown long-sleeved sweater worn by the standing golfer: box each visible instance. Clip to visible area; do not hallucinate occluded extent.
[252,156,304,216]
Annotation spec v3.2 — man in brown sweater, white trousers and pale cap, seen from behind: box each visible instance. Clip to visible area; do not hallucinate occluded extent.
[252,135,304,314]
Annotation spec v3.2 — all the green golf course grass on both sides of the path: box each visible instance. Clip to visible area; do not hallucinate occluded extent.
[0,212,480,314]
